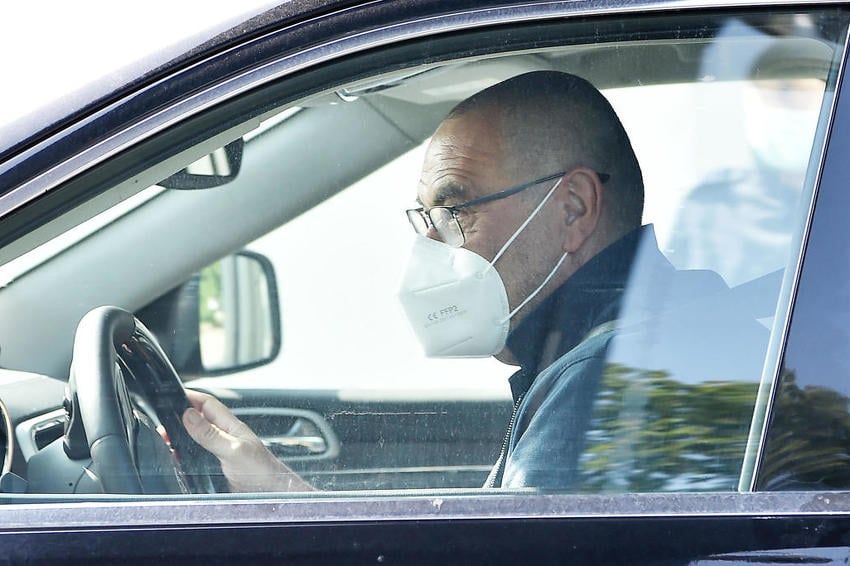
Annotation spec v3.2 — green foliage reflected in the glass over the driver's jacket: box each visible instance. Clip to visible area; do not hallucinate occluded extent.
[577,364,758,493]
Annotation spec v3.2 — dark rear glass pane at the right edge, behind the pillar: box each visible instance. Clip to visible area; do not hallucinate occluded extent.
[754,44,850,491]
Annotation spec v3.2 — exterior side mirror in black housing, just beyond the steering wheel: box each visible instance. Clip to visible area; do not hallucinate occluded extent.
[136,251,281,381]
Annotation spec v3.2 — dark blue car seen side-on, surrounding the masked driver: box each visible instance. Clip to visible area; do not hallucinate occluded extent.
[0,0,850,564]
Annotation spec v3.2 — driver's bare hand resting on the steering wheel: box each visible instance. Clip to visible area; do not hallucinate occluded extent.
[183,390,313,492]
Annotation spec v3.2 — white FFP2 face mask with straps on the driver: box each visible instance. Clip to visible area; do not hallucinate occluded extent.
[399,176,567,358]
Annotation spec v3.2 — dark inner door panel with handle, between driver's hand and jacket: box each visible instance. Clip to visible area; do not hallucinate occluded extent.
[200,389,512,490]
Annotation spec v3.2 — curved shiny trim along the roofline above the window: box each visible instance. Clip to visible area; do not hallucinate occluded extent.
[0,0,846,222]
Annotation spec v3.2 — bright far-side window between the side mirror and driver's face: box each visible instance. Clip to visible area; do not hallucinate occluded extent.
[216,138,513,399]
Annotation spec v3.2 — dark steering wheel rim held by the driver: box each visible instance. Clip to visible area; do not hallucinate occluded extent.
[71,306,213,494]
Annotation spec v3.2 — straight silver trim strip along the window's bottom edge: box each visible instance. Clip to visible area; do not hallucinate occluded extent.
[0,490,850,532]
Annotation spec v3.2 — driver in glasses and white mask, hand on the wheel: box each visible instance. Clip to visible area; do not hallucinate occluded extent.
[184,71,712,491]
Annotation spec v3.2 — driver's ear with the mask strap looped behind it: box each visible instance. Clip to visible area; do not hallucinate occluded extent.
[561,167,603,254]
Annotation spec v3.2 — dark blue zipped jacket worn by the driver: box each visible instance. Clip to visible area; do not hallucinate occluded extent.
[489,226,767,490]
